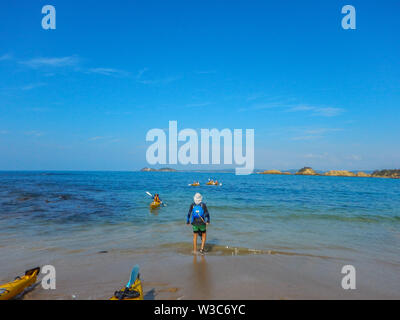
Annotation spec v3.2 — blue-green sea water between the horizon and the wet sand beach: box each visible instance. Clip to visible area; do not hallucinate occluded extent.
[0,172,400,273]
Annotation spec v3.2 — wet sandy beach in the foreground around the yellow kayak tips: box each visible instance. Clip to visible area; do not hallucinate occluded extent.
[1,251,400,300]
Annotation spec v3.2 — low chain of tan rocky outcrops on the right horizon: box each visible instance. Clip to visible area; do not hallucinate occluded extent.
[258,167,400,179]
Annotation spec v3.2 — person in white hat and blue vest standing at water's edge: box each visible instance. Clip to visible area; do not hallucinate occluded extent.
[186,193,210,253]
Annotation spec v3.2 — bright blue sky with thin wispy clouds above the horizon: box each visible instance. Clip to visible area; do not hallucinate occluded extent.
[0,0,400,170]
